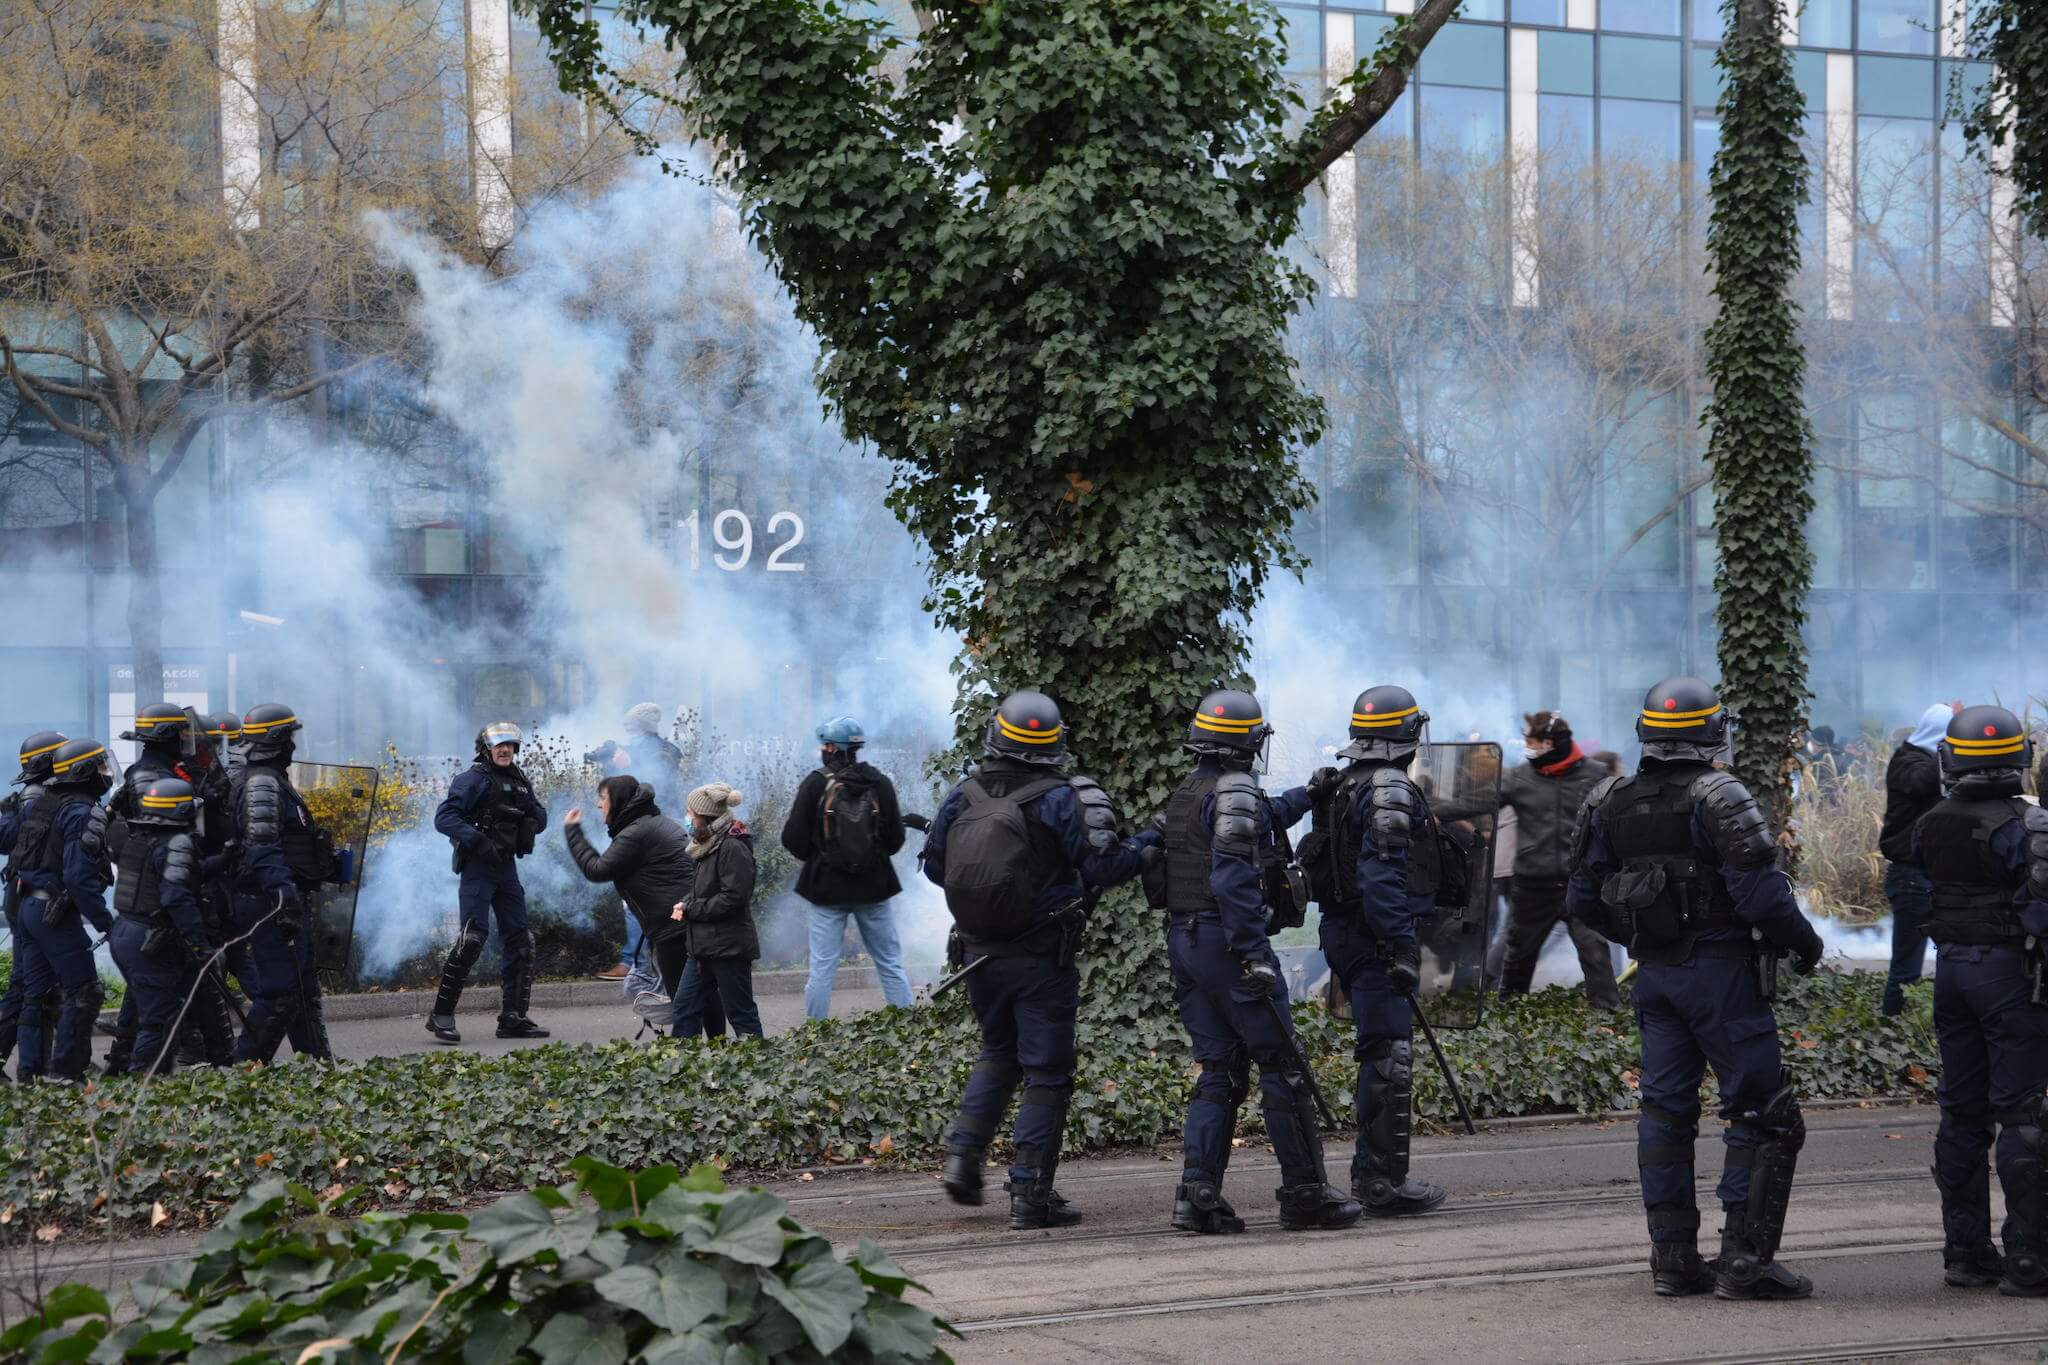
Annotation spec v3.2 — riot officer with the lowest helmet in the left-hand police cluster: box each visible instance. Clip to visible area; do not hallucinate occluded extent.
[109,778,211,1072]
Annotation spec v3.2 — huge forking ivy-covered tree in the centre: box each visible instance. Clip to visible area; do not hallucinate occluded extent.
[522,0,1456,1038]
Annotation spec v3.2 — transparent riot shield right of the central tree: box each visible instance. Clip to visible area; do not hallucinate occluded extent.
[1409,743,1501,1029]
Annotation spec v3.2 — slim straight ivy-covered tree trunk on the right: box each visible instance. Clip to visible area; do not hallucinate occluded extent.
[1702,0,1812,829]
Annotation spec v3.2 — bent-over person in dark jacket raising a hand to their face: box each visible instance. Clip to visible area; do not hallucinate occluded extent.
[561,776,725,1038]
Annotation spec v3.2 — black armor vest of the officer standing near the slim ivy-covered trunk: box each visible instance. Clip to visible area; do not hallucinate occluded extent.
[1599,763,1749,964]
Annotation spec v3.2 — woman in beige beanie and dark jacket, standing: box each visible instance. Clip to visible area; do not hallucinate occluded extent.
[672,782,762,1038]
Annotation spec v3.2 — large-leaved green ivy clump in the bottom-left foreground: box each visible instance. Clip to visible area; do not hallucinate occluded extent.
[0,1160,952,1365]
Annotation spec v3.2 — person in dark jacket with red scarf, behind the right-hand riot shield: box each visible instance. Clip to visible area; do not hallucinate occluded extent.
[1438,710,1622,1009]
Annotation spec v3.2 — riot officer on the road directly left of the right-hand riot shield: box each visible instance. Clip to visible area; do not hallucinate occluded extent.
[1309,688,1444,1218]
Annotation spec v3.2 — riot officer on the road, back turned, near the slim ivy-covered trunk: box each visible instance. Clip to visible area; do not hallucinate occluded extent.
[1569,677,1821,1300]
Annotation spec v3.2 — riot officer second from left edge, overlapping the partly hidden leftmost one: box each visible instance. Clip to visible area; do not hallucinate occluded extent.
[10,739,113,1081]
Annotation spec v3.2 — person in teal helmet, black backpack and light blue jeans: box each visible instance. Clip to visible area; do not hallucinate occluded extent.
[782,716,909,1019]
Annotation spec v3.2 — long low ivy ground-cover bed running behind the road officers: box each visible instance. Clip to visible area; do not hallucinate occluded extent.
[0,972,1937,1234]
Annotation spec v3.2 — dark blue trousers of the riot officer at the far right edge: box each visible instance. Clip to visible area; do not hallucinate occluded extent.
[1933,943,2048,1254]
